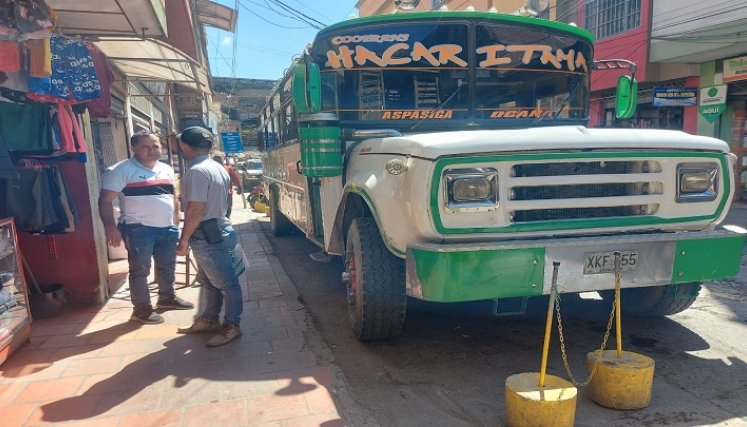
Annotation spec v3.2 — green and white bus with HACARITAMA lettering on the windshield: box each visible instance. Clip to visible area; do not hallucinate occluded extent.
[261,11,744,341]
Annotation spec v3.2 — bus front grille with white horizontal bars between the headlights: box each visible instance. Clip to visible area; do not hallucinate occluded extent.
[507,160,663,223]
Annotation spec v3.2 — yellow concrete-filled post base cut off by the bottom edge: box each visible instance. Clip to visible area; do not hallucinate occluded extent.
[506,372,578,427]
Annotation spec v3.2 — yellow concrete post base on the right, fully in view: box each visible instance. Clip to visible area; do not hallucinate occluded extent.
[586,350,655,409]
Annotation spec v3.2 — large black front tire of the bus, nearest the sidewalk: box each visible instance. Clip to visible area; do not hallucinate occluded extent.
[345,218,407,341]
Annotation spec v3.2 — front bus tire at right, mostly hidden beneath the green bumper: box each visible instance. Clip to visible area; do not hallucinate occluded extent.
[604,282,700,317]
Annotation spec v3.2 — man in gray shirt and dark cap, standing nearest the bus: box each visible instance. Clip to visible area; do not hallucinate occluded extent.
[176,126,244,347]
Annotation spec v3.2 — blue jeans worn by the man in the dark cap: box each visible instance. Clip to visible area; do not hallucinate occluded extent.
[189,225,244,326]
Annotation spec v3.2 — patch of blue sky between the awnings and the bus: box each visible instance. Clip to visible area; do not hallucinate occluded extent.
[207,0,358,80]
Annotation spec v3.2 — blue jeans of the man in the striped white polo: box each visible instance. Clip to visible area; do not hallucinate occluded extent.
[119,224,179,307]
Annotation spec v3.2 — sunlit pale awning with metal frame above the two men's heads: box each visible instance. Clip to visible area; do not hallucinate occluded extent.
[95,38,211,94]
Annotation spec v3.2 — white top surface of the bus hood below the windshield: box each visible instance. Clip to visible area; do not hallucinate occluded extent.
[354,126,729,159]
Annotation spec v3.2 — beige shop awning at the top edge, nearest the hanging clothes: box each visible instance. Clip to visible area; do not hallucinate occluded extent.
[47,0,168,38]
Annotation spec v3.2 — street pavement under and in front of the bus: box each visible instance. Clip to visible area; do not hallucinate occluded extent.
[260,205,747,427]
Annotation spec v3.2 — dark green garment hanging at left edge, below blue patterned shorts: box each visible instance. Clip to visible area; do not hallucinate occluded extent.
[0,102,52,154]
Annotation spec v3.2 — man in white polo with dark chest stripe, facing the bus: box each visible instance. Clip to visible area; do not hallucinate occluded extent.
[99,131,194,324]
